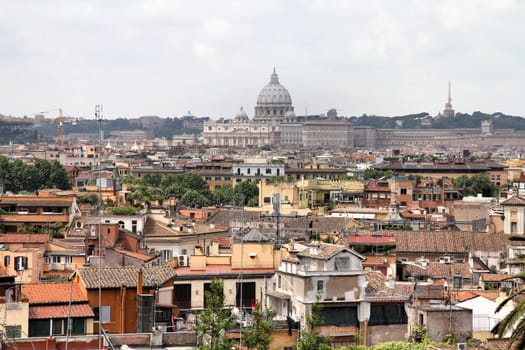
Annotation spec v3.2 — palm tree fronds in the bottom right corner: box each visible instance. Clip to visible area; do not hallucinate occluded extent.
[491,272,525,349]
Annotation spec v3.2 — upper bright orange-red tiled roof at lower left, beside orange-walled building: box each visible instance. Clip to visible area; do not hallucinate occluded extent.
[22,282,88,305]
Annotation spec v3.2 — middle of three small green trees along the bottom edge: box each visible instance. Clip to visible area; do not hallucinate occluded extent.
[242,303,275,350]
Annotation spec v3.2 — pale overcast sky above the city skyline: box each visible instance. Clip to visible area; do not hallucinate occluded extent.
[0,0,525,118]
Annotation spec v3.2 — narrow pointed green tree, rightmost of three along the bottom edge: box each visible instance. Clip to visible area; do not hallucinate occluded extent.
[297,294,331,350]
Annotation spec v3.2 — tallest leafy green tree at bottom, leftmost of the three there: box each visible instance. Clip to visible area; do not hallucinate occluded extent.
[194,278,233,350]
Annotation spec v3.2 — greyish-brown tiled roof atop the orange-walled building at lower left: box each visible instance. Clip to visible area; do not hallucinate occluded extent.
[77,266,176,289]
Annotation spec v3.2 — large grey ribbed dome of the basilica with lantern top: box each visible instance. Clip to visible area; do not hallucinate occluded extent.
[254,68,293,121]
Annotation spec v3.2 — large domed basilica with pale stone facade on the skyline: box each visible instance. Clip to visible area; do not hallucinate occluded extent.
[202,69,295,147]
